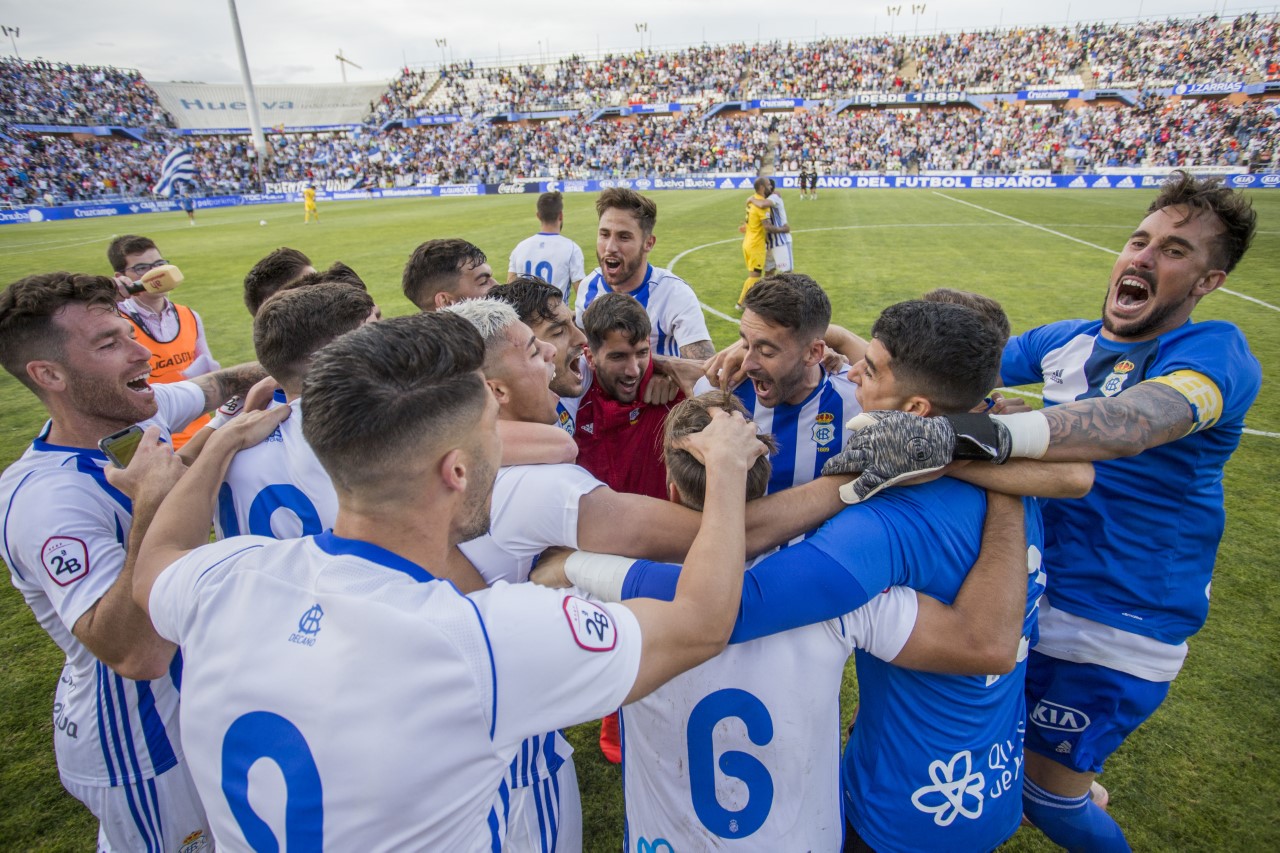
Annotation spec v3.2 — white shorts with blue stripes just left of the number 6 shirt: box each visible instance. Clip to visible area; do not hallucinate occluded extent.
[502,756,582,853]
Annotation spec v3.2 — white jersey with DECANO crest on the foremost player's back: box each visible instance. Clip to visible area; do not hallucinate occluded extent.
[150,533,641,853]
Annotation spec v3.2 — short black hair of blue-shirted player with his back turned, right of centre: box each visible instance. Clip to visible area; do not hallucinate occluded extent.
[872,300,1001,414]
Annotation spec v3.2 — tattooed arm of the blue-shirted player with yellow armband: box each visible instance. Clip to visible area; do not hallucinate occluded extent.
[1043,382,1194,462]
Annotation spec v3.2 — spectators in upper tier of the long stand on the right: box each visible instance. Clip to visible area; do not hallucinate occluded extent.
[370,13,1280,122]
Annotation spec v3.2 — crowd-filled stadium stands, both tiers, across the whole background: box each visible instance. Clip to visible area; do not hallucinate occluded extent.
[0,14,1280,206]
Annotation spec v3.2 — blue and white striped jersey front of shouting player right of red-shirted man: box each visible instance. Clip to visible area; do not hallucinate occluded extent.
[694,366,861,494]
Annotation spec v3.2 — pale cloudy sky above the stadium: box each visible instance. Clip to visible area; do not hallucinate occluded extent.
[0,0,1254,83]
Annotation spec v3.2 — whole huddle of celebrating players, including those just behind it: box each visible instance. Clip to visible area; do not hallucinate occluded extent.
[0,173,1261,853]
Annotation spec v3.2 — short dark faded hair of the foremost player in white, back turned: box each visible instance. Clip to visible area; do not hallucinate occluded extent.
[302,313,489,494]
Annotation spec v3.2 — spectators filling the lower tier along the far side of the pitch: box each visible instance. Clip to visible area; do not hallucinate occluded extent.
[0,99,1280,205]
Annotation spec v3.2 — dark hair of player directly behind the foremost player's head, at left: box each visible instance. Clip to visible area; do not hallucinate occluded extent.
[253,283,374,388]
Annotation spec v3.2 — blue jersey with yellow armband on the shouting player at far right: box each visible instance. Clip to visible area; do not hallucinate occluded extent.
[1001,320,1262,644]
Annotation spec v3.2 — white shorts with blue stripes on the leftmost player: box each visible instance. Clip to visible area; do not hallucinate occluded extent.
[63,765,214,853]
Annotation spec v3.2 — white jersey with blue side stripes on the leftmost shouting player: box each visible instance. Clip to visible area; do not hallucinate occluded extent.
[0,382,205,788]
